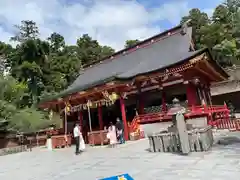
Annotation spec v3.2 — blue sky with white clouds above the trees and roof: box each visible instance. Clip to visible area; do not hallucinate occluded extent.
[0,0,223,50]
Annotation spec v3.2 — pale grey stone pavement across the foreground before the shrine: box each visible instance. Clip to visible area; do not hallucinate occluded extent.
[0,131,240,180]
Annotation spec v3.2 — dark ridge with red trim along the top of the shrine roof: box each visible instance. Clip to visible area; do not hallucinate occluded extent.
[82,25,182,70]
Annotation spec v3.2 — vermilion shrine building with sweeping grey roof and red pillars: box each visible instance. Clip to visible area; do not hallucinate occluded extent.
[40,25,234,145]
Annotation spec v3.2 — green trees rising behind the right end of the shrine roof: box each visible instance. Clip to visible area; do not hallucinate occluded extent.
[181,0,240,66]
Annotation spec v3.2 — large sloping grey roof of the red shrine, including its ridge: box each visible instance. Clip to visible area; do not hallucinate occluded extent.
[39,26,227,102]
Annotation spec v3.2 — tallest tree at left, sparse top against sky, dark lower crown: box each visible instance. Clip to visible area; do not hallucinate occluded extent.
[7,21,50,104]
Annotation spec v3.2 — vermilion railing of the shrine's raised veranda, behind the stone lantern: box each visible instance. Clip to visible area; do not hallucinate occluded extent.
[129,105,232,132]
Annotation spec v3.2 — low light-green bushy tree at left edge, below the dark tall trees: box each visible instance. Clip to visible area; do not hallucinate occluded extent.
[0,76,50,133]
